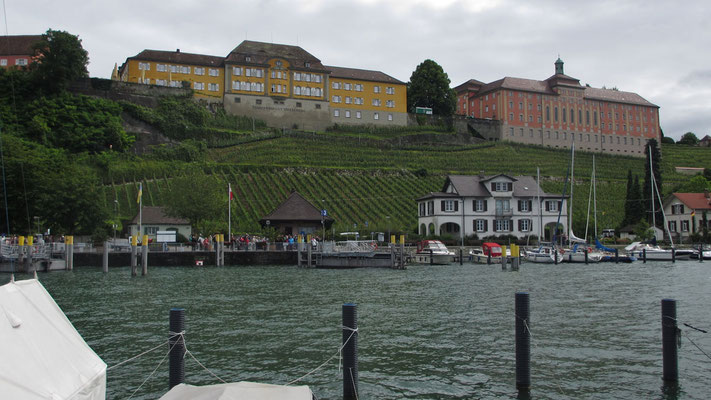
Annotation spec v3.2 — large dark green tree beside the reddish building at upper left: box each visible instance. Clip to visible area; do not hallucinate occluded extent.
[30,29,89,93]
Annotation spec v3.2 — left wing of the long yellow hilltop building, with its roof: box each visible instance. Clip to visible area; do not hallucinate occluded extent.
[118,49,225,101]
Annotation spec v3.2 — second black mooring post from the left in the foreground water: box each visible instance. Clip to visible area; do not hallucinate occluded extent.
[342,303,358,400]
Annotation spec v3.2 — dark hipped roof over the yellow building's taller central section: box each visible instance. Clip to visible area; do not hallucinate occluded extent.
[225,40,327,72]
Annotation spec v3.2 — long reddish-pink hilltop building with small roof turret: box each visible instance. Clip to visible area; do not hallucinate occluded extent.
[455,58,661,157]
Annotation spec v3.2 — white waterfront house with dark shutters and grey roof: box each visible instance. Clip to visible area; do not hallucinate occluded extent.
[416,174,568,240]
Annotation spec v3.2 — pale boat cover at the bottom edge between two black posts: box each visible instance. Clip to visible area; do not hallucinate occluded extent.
[160,382,311,400]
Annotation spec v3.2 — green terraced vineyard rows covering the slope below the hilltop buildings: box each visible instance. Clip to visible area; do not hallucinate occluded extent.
[105,137,711,238]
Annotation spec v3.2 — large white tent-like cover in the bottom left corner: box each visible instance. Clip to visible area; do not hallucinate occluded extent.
[0,279,106,400]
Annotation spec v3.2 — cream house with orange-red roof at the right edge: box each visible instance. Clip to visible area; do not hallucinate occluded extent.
[664,191,711,241]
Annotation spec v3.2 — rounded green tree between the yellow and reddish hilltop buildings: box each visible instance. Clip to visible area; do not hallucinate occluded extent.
[407,59,457,115]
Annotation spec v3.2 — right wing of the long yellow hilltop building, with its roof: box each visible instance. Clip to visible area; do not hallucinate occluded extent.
[326,66,407,125]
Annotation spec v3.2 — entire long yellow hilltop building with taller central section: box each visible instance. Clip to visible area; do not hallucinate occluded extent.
[118,40,407,130]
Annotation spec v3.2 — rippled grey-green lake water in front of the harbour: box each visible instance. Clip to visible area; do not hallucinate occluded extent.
[3,261,711,399]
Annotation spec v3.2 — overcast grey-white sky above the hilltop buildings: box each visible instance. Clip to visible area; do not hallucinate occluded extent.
[2,0,711,139]
